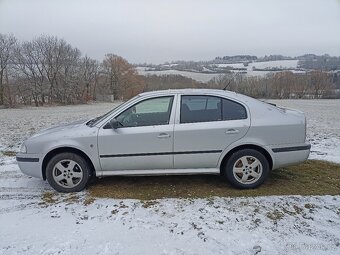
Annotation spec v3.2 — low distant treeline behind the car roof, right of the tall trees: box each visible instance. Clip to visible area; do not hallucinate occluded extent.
[144,70,340,99]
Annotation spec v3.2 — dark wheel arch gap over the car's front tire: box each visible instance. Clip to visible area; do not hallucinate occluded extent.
[41,147,96,180]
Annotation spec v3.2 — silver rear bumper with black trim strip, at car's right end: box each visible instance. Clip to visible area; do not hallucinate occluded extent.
[270,143,311,169]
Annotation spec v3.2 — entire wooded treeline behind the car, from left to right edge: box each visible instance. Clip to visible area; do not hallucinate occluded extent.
[0,34,340,107]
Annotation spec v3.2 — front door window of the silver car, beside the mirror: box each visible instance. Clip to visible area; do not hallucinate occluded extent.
[116,96,173,127]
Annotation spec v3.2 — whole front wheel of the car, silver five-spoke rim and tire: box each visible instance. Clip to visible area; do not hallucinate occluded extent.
[46,152,91,193]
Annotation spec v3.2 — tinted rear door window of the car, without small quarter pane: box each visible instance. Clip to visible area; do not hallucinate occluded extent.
[180,96,222,123]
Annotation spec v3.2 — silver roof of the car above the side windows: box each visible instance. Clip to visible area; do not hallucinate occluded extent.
[139,89,237,96]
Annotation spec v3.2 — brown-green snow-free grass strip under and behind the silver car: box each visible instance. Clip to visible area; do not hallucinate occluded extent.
[89,160,340,200]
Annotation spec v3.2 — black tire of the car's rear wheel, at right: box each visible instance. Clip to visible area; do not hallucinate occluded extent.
[222,149,269,189]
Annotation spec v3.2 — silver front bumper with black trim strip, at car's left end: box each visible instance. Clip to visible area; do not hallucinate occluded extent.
[16,153,43,179]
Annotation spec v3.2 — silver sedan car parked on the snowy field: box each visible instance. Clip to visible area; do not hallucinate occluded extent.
[16,89,310,192]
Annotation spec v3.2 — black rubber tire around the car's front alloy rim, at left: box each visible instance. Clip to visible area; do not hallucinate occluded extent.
[46,152,91,193]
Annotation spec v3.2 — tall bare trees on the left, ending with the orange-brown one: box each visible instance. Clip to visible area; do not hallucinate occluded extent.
[0,34,143,106]
